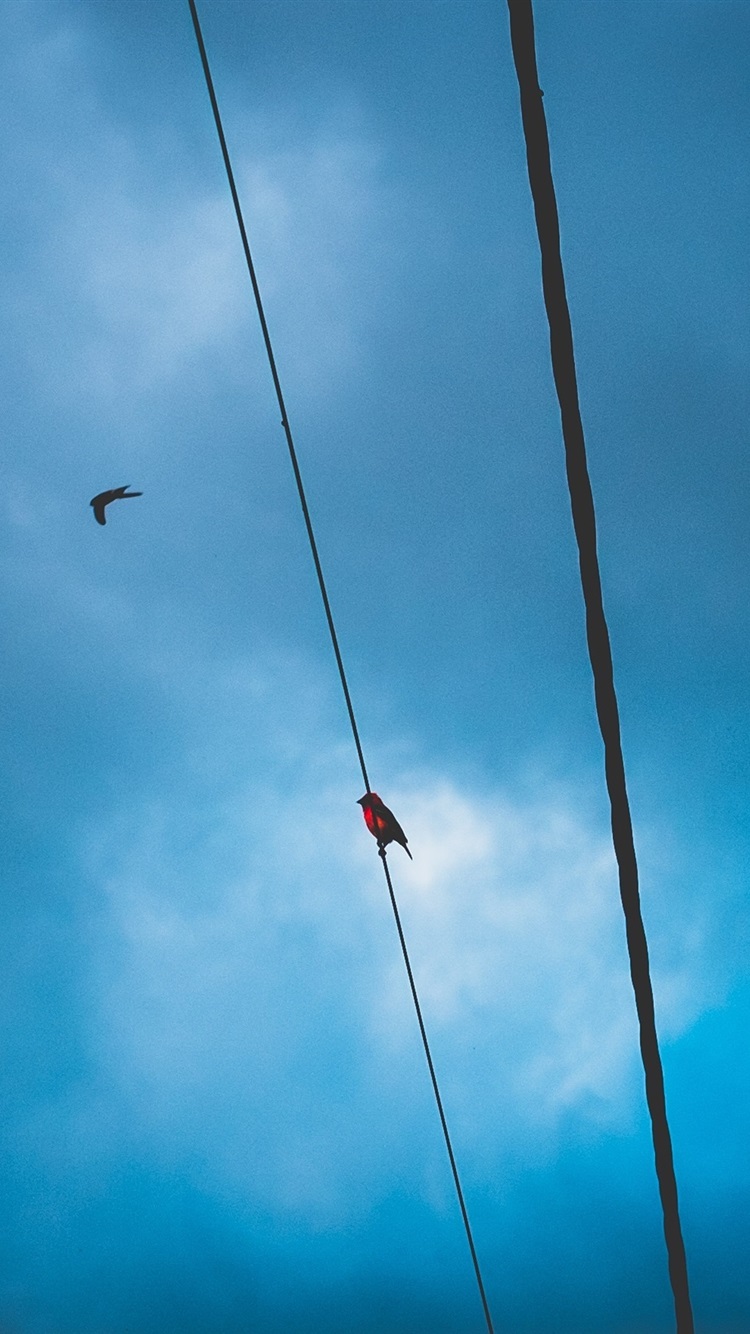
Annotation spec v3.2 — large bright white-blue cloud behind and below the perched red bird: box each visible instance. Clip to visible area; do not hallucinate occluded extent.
[51,642,702,1230]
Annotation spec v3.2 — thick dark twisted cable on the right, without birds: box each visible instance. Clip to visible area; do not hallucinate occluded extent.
[508,0,694,1334]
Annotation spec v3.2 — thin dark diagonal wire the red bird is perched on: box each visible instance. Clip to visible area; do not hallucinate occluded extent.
[188,0,494,1334]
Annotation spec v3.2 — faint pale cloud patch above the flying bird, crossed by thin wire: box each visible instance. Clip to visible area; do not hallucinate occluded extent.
[47,127,392,398]
